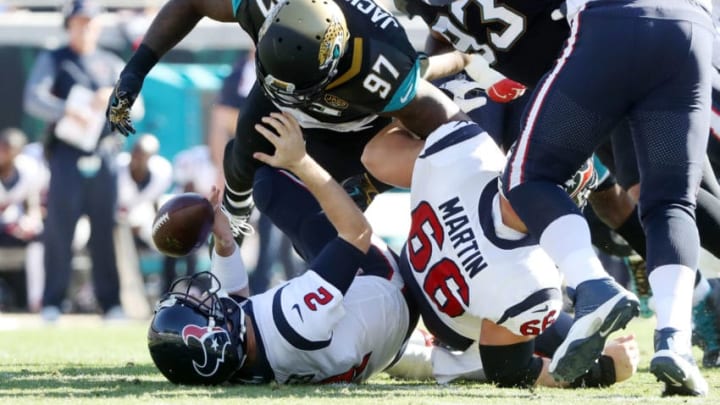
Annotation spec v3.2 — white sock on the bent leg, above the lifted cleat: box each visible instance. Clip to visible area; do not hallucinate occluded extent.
[540,214,610,288]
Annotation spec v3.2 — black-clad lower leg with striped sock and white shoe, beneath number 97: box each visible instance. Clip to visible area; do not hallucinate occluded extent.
[222,83,279,245]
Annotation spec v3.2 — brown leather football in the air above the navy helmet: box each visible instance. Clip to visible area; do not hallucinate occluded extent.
[152,193,215,257]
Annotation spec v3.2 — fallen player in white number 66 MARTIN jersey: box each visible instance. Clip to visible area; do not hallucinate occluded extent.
[363,121,637,387]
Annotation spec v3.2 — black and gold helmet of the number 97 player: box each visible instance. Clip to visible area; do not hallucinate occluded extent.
[255,0,350,108]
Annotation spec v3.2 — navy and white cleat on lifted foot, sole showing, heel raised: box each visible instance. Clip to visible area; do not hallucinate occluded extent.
[549,278,639,381]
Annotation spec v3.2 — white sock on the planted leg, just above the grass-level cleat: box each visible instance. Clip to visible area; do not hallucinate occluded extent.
[649,264,695,332]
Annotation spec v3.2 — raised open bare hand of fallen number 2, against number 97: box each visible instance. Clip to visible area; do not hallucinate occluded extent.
[253,113,307,171]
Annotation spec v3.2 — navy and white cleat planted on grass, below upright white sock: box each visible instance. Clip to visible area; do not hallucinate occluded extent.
[650,328,708,396]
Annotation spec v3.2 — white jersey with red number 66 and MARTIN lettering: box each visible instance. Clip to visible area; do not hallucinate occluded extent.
[400,122,562,350]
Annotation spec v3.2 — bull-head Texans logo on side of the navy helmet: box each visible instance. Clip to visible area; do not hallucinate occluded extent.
[182,325,230,377]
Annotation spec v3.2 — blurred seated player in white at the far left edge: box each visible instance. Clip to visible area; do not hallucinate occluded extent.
[0,128,48,312]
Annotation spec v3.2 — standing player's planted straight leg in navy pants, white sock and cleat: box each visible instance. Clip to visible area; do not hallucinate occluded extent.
[630,15,712,395]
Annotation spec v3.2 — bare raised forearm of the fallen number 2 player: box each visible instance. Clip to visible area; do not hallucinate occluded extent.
[289,155,372,252]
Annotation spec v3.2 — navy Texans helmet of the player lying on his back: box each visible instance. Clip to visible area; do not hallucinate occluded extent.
[148,272,247,385]
